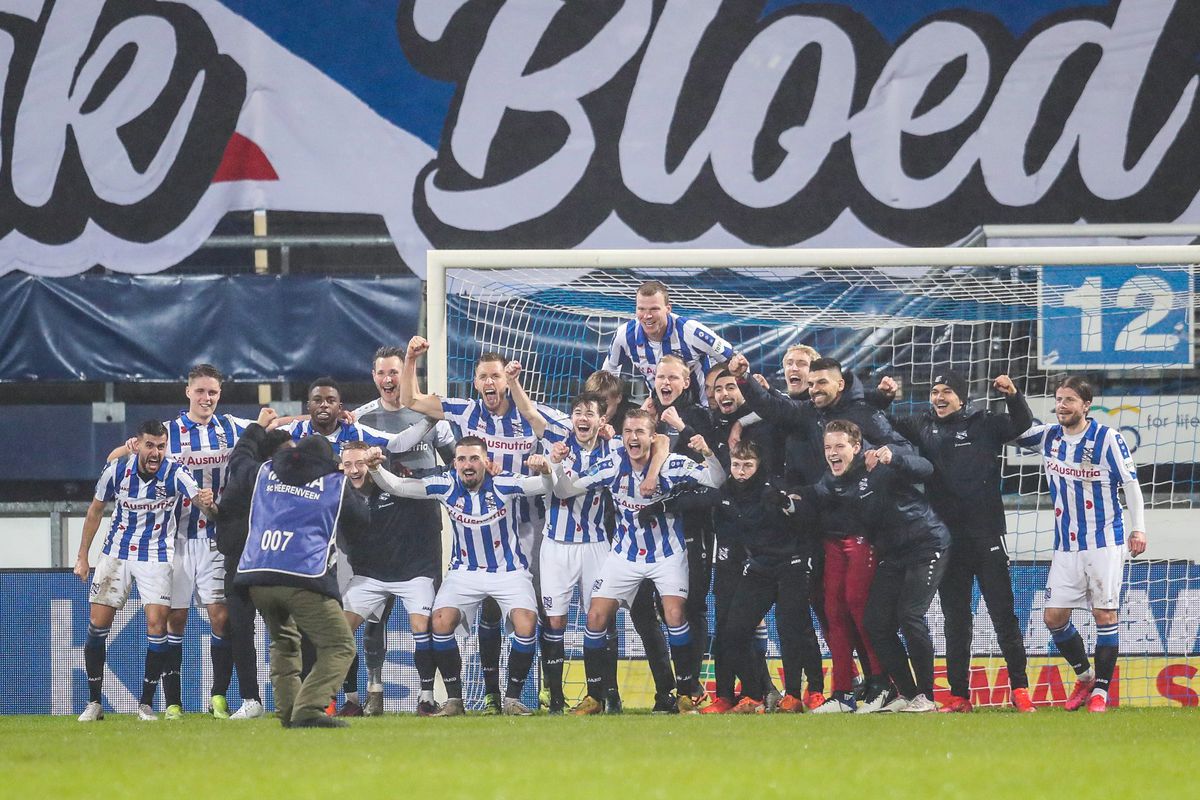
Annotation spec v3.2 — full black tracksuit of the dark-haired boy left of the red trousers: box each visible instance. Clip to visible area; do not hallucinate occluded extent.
[678,474,823,700]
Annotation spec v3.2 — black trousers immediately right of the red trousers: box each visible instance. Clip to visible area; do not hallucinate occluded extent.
[863,551,950,699]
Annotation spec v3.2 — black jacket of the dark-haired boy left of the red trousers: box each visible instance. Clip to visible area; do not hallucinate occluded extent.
[668,474,812,566]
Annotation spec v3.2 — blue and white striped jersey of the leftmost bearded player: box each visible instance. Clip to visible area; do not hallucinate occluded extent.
[96,453,200,561]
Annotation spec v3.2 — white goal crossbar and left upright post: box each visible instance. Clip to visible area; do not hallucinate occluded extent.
[425,245,1200,396]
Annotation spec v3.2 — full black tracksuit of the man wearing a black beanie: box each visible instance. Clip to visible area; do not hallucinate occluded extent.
[894,393,1033,698]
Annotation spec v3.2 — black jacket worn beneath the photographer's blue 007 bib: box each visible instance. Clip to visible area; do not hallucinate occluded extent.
[234,435,368,600]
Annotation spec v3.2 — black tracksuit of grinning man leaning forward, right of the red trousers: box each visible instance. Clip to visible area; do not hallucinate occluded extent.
[802,451,950,699]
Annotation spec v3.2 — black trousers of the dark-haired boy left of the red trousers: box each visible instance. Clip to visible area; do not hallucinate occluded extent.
[718,558,823,700]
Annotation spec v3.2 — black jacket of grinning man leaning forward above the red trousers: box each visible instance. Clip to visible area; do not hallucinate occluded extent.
[800,451,950,561]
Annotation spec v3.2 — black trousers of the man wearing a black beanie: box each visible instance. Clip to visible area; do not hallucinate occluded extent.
[937,536,1030,698]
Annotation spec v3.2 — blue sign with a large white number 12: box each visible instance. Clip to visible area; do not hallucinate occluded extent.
[1038,265,1195,369]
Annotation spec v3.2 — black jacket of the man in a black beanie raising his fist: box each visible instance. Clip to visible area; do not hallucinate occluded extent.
[894,393,1033,537]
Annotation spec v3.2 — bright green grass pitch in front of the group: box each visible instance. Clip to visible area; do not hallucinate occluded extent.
[0,709,1200,800]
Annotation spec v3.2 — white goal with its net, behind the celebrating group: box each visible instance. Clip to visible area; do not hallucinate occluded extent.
[428,247,1200,705]
